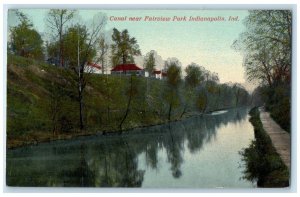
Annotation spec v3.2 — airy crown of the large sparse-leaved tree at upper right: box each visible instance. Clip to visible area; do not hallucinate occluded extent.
[233,10,292,86]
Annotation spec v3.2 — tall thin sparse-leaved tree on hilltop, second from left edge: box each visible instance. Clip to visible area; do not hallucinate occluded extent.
[46,9,75,67]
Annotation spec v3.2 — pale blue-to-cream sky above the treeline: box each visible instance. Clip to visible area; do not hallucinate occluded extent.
[8,9,252,87]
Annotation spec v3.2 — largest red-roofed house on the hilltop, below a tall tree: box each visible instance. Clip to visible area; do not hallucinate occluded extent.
[111,64,143,76]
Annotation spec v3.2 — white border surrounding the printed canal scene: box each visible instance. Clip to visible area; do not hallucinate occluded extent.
[0,0,299,196]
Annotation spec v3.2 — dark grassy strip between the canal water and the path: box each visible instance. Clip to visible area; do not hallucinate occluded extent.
[241,108,289,187]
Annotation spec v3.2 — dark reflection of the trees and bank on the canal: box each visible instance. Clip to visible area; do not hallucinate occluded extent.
[6,108,248,187]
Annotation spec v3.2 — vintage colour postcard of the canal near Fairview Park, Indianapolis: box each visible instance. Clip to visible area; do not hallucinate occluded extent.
[5,8,294,189]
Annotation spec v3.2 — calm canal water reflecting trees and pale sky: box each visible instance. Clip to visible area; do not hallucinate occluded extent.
[6,108,255,188]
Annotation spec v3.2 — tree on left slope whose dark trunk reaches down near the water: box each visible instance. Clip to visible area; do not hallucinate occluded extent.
[64,15,106,130]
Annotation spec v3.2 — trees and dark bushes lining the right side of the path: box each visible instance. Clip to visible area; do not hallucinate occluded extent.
[233,10,292,132]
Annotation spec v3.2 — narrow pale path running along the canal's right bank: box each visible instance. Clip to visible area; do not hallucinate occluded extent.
[260,109,291,170]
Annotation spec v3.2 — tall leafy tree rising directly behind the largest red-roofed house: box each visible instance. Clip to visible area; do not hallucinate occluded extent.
[111,28,141,66]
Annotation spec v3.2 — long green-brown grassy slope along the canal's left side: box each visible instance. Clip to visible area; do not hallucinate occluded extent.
[6,54,248,147]
